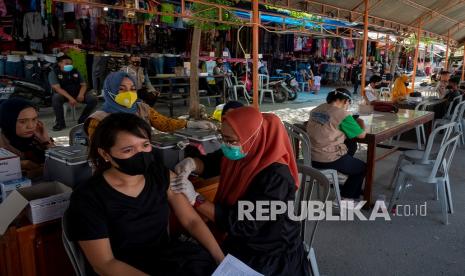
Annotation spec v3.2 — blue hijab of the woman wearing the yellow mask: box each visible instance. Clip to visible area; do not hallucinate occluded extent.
[102,71,138,114]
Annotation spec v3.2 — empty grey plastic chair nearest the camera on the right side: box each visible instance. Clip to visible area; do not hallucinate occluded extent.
[388,133,460,224]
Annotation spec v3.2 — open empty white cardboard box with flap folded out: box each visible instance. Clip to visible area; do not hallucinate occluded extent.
[0,182,72,235]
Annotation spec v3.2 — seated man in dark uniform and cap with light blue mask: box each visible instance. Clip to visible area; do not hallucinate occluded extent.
[48,55,97,131]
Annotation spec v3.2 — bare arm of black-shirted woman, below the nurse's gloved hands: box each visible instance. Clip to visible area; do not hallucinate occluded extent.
[168,189,224,264]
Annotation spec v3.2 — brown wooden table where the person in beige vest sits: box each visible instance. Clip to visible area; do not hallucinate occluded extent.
[357,109,434,206]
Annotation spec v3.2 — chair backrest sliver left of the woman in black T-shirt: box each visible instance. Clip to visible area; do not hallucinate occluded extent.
[61,211,92,276]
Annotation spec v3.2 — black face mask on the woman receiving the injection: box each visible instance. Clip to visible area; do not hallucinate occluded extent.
[111,151,154,175]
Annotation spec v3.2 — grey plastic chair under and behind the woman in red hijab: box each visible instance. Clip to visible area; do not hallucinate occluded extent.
[294,165,331,276]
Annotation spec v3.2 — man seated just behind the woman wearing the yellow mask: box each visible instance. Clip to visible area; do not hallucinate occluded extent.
[121,54,160,106]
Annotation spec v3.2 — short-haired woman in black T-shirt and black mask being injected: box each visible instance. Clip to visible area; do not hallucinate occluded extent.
[68,113,224,275]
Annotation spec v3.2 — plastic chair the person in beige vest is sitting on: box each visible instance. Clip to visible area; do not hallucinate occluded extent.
[283,122,341,206]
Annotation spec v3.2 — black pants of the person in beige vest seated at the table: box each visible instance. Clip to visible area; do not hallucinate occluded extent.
[312,140,366,199]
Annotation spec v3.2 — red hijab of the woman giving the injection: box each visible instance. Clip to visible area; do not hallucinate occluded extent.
[215,107,299,205]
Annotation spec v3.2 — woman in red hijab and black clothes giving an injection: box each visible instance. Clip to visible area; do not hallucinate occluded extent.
[171,107,310,276]
